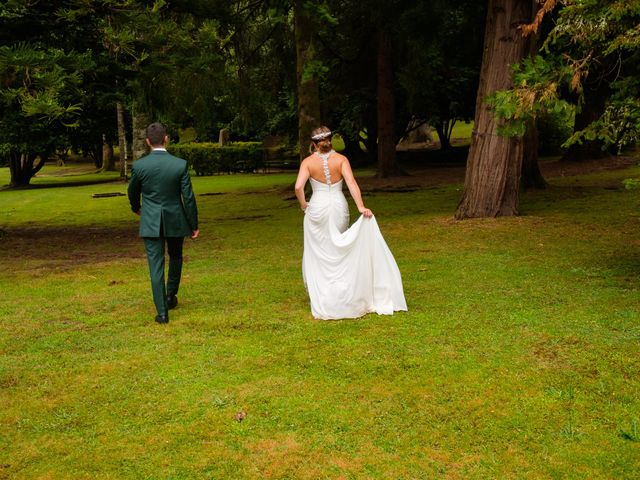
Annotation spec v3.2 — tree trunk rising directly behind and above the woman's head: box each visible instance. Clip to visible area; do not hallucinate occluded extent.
[293,0,320,161]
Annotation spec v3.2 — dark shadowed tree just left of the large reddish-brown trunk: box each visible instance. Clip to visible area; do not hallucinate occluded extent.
[398,0,487,150]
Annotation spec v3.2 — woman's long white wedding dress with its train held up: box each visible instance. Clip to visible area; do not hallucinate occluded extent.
[302,178,407,320]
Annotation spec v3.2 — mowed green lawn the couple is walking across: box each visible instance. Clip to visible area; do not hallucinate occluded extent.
[0,162,640,479]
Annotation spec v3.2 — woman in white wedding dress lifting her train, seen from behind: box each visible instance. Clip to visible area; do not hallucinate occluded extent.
[295,127,407,320]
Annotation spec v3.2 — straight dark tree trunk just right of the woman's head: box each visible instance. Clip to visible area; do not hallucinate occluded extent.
[378,28,397,178]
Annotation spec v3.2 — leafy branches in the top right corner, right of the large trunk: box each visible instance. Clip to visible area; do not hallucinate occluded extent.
[548,0,640,160]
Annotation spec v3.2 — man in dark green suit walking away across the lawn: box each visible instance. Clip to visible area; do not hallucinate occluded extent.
[128,123,200,323]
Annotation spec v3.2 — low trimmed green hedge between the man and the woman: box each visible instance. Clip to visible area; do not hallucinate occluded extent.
[168,142,265,176]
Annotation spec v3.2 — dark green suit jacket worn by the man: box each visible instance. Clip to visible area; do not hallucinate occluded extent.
[128,150,198,237]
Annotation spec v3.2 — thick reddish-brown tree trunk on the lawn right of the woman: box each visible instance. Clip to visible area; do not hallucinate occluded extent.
[456,0,534,219]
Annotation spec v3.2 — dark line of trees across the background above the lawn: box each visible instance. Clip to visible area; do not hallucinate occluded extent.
[0,0,640,218]
